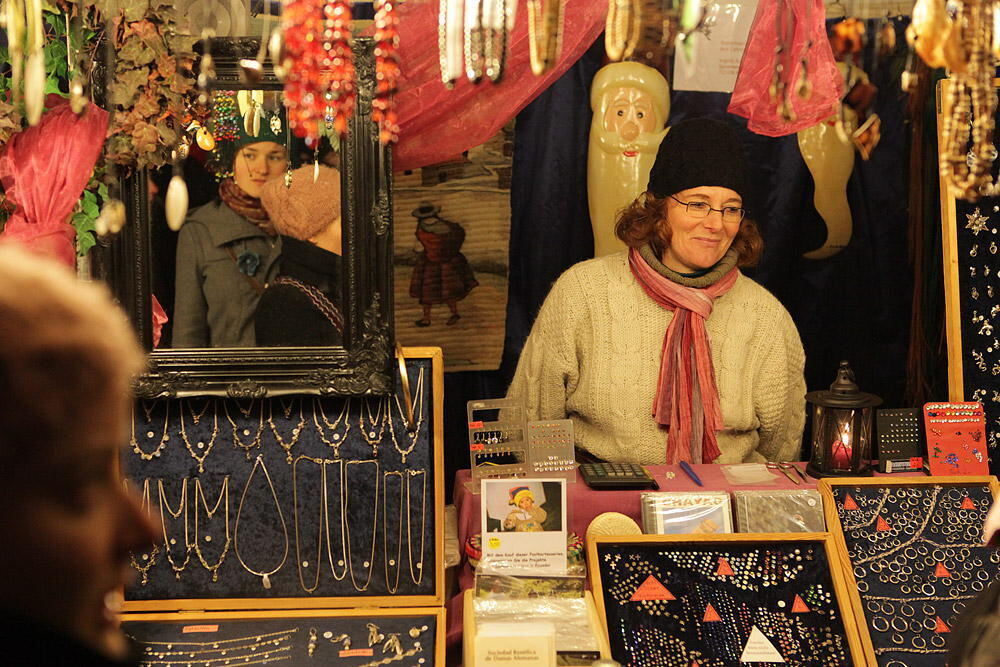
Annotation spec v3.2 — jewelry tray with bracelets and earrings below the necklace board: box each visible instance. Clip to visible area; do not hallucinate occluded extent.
[122,608,445,667]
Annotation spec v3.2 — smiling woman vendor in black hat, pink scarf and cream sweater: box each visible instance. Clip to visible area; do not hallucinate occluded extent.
[508,119,805,464]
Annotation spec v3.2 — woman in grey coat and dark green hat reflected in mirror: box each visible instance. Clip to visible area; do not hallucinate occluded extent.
[173,124,288,348]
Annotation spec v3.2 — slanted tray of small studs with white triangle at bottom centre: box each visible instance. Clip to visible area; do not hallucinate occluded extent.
[588,533,866,667]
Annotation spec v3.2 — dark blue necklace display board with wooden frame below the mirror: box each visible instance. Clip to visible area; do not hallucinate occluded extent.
[123,348,444,611]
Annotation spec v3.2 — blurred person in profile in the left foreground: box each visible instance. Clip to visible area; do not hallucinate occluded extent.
[0,244,155,667]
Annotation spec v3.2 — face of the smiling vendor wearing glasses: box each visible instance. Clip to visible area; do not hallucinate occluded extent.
[662,185,743,273]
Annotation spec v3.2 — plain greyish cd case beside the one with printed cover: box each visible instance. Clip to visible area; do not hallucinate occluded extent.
[733,489,826,533]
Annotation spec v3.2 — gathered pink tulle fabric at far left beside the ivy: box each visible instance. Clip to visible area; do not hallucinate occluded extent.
[0,102,108,266]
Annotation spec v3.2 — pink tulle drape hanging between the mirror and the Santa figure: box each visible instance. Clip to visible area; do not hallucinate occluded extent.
[393,0,608,171]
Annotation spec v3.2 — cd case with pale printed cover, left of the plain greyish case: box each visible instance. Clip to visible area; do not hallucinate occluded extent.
[642,491,733,535]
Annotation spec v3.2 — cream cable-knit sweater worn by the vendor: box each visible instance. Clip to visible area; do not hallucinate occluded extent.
[507,252,806,464]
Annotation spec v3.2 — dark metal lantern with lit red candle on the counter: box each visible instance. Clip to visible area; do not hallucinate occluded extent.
[806,361,882,477]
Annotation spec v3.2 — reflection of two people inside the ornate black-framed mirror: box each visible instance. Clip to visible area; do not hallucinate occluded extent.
[149,90,344,349]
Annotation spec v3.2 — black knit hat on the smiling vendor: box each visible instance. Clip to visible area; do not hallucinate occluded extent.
[646,118,749,199]
